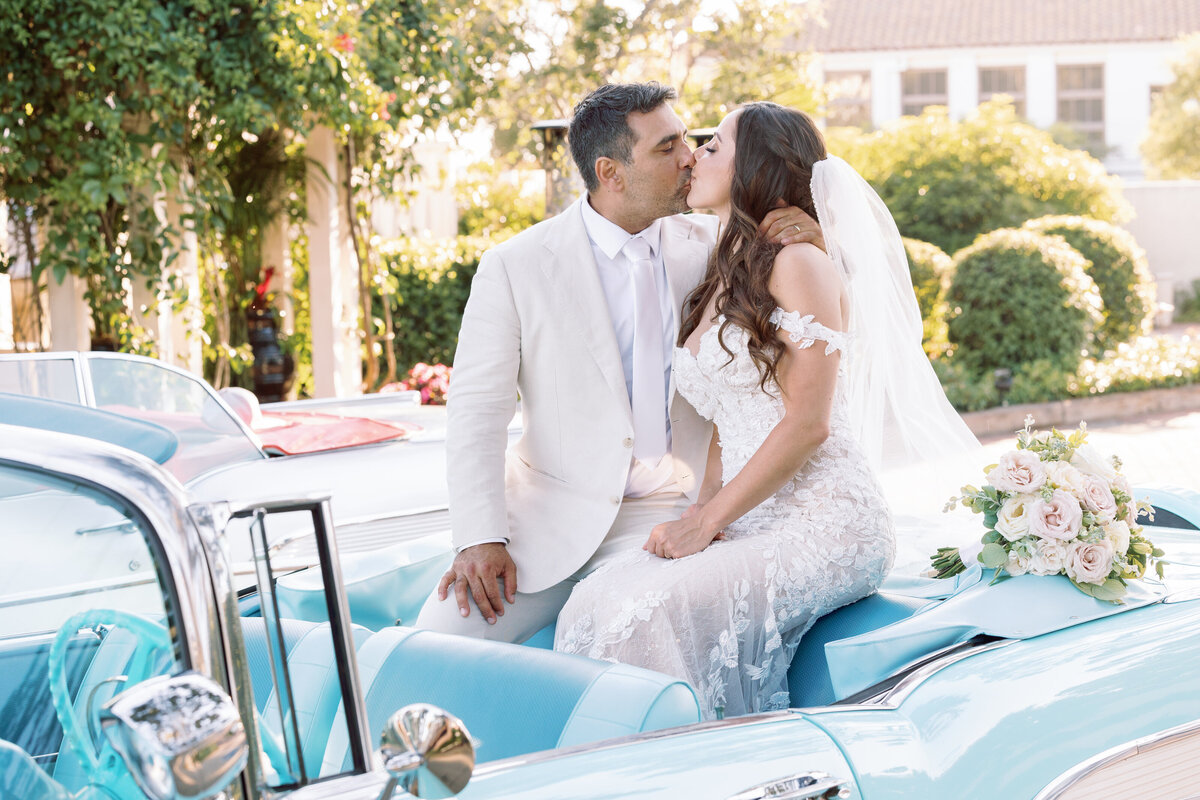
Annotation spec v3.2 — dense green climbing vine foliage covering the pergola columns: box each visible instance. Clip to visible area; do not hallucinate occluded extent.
[0,0,514,381]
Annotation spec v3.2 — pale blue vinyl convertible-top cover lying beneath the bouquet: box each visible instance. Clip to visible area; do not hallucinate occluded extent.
[826,570,1165,699]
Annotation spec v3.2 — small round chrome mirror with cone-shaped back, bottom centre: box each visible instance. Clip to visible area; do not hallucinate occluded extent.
[379,703,475,800]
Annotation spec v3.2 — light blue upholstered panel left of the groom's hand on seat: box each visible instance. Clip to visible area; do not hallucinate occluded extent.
[276,536,454,631]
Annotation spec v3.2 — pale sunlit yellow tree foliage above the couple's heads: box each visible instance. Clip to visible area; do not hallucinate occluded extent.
[490,0,818,161]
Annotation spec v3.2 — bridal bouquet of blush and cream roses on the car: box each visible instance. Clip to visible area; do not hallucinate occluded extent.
[931,416,1164,603]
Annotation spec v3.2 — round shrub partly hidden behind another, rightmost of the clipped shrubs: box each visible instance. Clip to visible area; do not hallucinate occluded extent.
[1024,216,1154,350]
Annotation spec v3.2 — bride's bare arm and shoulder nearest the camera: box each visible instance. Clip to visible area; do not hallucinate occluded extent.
[644,245,844,558]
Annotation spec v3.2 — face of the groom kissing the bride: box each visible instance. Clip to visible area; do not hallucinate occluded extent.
[624,104,696,219]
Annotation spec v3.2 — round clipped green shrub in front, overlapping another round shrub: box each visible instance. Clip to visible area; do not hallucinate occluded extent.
[947,228,1102,372]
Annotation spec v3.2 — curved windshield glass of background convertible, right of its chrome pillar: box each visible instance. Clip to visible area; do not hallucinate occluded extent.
[88,354,265,482]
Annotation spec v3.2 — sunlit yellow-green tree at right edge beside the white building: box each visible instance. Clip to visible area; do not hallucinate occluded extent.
[1141,35,1200,178]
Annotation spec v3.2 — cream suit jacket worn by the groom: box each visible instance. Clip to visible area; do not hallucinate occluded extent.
[446,198,716,593]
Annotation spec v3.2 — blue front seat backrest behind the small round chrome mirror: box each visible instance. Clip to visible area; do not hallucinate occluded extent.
[322,627,700,774]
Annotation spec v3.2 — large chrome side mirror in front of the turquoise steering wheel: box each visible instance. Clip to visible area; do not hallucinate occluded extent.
[100,673,250,800]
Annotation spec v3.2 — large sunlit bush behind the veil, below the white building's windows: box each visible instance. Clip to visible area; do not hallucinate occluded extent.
[828,101,1130,253]
